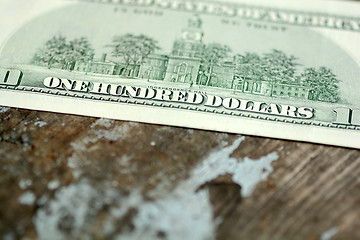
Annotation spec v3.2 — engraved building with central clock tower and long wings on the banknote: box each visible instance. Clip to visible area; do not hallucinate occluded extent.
[74,16,309,99]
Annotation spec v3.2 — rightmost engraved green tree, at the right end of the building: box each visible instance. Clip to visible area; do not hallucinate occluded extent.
[301,67,340,103]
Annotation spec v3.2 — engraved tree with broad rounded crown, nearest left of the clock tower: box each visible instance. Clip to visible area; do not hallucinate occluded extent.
[107,34,160,76]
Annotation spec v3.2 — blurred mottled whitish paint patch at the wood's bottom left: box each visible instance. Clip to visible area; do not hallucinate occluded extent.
[34,181,121,240]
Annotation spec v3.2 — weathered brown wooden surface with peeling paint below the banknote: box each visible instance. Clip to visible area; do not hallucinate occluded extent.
[0,108,360,240]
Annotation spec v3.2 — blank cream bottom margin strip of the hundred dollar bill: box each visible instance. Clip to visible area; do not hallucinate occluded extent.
[0,89,360,149]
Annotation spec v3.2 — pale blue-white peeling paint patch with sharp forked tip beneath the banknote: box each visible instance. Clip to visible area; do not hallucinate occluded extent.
[117,137,278,240]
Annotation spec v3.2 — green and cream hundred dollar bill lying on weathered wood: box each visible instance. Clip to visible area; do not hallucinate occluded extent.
[0,0,360,148]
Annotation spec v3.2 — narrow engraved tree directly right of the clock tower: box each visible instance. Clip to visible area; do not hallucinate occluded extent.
[200,43,231,86]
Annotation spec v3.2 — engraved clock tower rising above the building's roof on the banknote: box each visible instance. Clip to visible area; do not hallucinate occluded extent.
[172,16,204,58]
